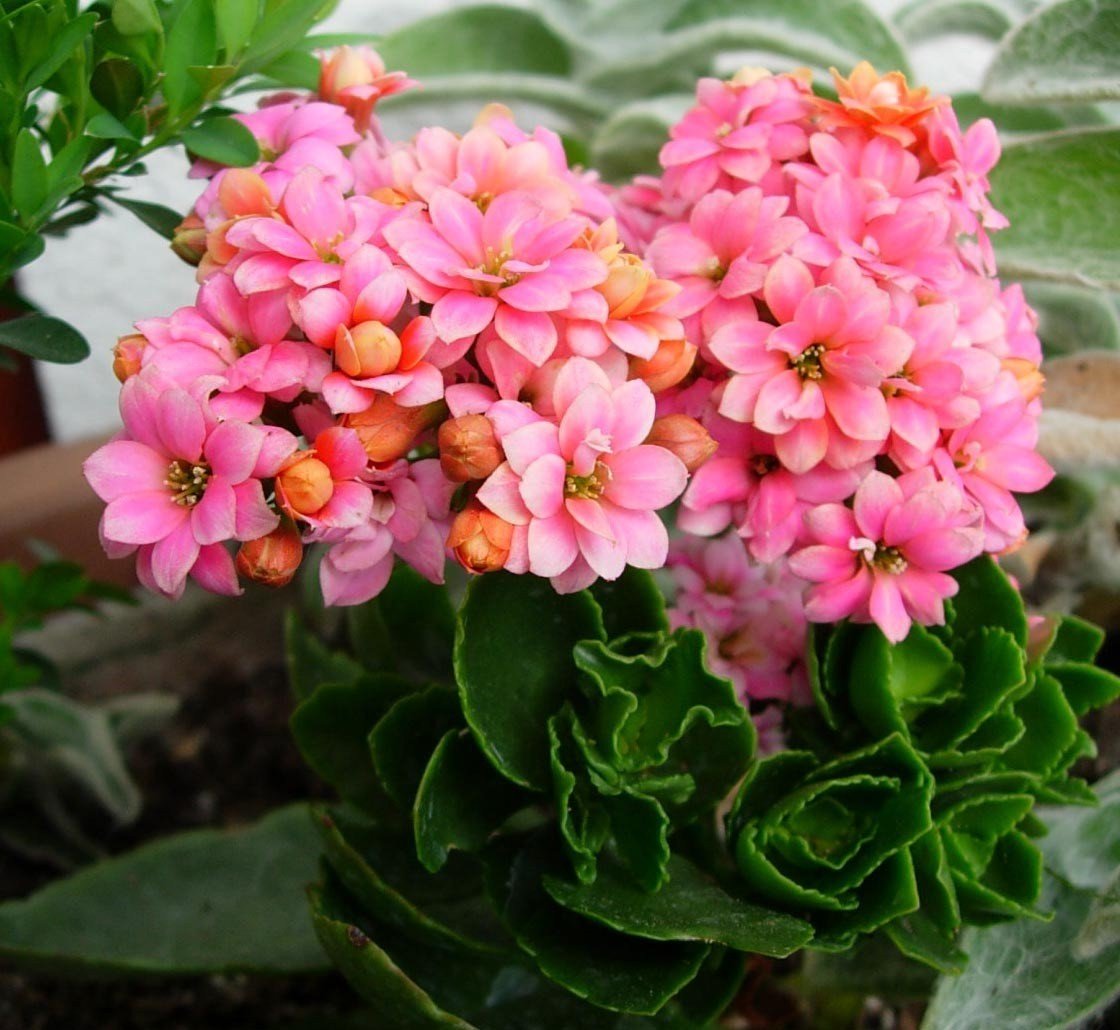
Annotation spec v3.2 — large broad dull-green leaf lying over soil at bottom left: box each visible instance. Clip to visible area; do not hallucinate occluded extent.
[0,805,327,975]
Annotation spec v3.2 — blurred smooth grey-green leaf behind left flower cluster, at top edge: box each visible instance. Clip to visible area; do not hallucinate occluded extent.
[377,4,572,78]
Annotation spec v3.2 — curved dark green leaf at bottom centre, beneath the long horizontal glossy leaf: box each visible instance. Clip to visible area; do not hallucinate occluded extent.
[495,836,708,1015]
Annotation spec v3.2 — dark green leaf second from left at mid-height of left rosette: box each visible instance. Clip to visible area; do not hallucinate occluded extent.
[370,686,463,812]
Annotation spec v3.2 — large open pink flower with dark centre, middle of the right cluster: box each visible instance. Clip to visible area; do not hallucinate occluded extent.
[710,256,914,472]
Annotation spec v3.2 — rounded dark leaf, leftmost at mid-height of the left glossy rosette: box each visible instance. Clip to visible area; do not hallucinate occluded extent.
[290,673,411,812]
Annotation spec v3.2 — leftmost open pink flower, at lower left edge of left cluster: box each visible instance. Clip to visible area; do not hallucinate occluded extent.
[84,373,296,594]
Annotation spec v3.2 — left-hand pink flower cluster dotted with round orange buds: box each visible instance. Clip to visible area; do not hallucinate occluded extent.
[85,48,689,605]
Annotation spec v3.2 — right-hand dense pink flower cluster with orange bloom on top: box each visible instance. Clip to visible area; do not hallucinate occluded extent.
[614,64,1053,644]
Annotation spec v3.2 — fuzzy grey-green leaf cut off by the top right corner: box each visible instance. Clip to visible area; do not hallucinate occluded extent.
[983,0,1120,104]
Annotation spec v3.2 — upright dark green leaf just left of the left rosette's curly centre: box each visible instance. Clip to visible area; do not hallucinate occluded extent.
[412,730,528,872]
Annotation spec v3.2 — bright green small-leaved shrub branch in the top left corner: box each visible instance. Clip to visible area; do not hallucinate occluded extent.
[0,0,333,363]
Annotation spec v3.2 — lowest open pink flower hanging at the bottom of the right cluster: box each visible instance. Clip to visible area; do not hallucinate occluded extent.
[790,469,983,643]
